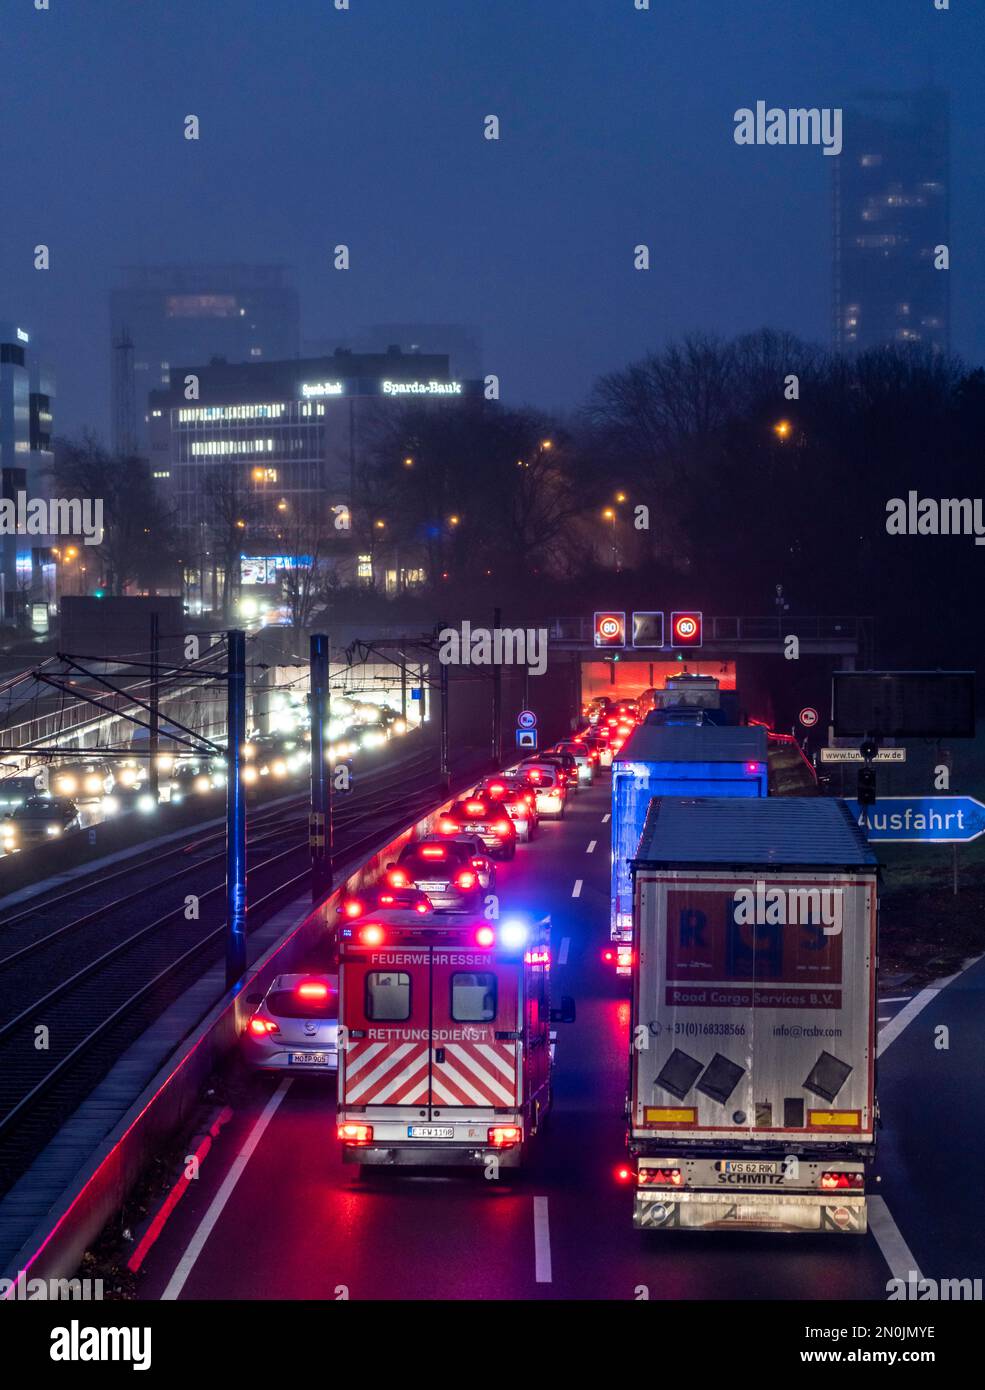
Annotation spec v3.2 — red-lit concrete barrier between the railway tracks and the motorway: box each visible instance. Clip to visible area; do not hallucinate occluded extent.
[3,796,456,1298]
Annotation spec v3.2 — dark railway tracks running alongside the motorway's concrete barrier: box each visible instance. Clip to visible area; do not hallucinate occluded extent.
[0,752,489,1194]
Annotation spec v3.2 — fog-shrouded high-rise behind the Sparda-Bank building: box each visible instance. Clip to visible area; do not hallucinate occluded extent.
[110,265,300,455]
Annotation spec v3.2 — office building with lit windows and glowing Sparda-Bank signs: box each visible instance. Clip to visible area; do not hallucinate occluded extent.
[149,348,481,610]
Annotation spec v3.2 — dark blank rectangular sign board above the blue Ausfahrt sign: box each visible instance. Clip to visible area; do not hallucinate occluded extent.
[831,671,975,738]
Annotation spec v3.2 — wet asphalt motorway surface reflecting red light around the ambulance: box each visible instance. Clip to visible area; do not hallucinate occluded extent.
[127,778,985,1300]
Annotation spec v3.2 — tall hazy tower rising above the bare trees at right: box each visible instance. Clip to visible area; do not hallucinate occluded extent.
[832,86,950,352]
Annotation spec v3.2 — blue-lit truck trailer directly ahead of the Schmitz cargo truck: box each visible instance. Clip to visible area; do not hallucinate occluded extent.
[610,723,767,942]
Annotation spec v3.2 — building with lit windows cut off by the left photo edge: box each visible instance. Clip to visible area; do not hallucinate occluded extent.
[0,322,56,627]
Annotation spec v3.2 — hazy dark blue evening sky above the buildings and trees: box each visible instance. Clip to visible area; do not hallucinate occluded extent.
[0,0,985,434]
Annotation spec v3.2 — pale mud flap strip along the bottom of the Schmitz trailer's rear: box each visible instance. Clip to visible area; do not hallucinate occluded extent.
[632,1193,868,1236]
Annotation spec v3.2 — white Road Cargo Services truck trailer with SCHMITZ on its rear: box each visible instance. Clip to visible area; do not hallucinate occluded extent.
[627,796,878,1234]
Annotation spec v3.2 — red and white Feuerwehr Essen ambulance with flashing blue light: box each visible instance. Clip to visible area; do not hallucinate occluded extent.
[338,912,575,1168]
